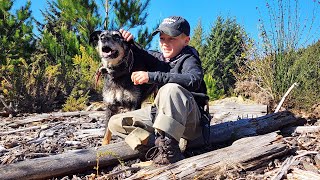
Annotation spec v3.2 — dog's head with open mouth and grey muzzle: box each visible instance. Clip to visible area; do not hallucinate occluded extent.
[90,31,129,67]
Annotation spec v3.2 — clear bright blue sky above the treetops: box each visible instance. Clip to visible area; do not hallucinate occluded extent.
[15,0,320,46]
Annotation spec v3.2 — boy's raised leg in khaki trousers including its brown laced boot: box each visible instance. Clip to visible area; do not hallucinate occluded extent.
[149,83,201,164]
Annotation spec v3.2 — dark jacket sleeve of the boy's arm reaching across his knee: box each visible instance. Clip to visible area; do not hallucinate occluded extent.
[148,55,203,92]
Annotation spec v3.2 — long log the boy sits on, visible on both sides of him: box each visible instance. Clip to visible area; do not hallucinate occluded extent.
[0,112,299,179]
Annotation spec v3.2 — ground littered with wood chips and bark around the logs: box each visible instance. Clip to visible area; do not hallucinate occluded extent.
[0,99,320,179]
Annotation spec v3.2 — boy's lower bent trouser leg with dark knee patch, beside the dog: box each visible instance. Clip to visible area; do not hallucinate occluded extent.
[108,106,154,150]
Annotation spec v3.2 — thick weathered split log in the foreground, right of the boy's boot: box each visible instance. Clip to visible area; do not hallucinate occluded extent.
[130,133,289,179]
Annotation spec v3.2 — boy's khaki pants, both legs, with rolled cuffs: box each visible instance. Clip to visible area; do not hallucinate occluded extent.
[108,83,201,150]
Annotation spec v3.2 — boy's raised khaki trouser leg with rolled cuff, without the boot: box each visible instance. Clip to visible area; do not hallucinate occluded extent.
[153,83,201,141]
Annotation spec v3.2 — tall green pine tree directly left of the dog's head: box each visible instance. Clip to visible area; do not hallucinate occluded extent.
[38,0,101,94]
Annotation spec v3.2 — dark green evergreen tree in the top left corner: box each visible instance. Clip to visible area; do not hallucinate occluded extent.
[0,0,34,65]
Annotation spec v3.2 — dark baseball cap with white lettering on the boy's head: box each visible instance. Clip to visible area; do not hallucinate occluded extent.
[152,16,190,37]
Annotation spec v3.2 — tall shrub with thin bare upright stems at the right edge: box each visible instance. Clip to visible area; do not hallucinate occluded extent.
[237,0,320,110]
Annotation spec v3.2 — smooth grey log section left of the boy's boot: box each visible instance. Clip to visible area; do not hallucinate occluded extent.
[0,142,138,180]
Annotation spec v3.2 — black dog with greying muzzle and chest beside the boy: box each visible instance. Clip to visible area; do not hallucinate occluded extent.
[90,30,156,145]
